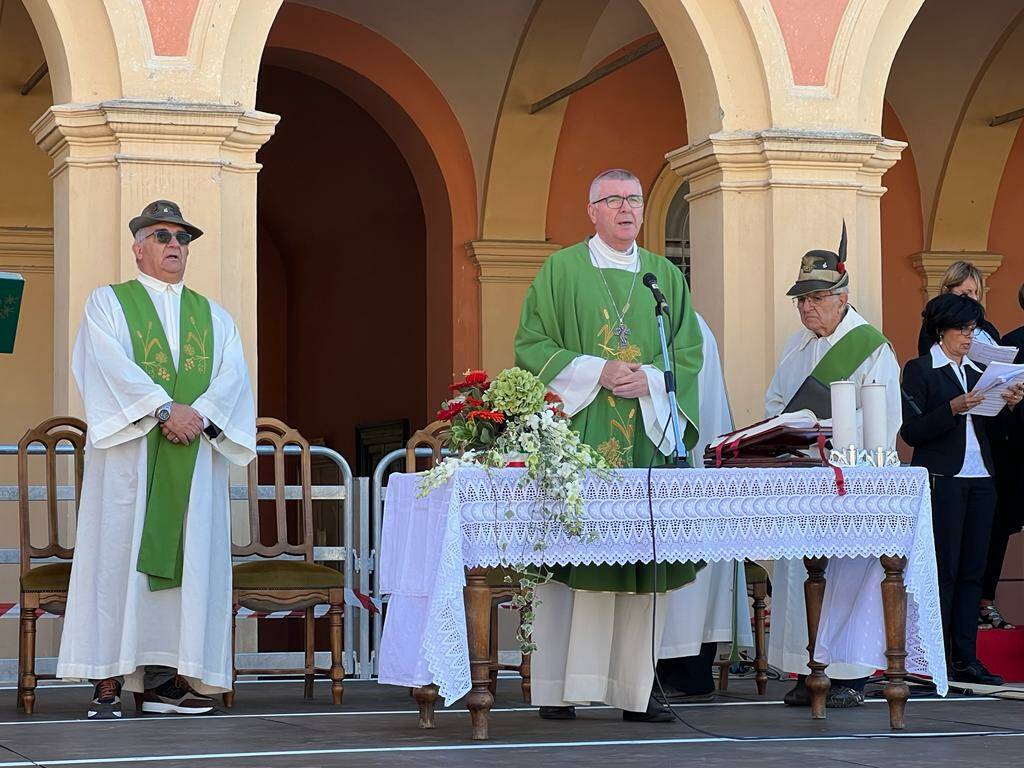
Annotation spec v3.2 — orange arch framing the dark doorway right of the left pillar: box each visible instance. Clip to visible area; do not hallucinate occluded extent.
[264,5,480,401]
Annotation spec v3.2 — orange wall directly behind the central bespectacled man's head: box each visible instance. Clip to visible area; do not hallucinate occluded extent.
[547,38,686,245]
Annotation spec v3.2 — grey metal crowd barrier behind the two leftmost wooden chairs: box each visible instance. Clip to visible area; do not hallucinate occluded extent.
[0,443,378,678]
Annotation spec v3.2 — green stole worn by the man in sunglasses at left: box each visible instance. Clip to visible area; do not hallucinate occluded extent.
[111,280,213,592]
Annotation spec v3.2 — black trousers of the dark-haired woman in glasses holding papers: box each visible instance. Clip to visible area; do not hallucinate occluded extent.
[932,475,995,665]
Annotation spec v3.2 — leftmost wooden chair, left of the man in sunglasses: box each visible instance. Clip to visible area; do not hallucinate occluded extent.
[17,416,86,715]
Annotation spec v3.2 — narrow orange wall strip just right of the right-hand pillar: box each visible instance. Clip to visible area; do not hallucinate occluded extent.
[881,103,925,365]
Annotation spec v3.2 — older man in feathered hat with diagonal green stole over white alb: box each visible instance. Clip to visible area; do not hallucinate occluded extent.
[765,224,903,709]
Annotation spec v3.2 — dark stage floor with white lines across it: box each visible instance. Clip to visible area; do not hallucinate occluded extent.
[0,678,1024,768]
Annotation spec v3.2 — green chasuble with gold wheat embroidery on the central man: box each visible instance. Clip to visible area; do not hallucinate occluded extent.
[515,243,703,593]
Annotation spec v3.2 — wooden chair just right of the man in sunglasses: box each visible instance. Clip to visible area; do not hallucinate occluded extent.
[224,419,345,707]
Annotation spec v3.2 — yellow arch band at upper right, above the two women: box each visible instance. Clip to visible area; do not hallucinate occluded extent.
[925,11,1024,253]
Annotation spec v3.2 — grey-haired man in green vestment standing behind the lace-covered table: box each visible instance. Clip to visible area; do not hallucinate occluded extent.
[515,171,702,720]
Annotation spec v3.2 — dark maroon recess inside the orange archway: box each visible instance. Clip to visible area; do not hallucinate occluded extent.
[259,68,427,464]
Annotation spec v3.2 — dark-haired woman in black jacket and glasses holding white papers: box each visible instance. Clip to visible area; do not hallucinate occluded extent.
[900,293,1024,685]
